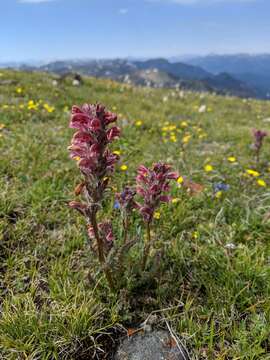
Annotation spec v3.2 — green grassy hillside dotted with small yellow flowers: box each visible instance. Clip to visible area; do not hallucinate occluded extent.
[0,70,270,360]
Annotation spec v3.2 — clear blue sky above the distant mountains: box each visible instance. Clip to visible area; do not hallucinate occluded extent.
[0,0,270,62]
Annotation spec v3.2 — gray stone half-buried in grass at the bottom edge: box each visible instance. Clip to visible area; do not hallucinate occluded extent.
[115,330,189,360]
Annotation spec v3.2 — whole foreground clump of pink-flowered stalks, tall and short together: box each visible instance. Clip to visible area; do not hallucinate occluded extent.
[69,104,179,290]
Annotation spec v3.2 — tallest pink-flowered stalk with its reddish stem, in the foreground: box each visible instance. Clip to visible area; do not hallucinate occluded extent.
[69,104,120,288]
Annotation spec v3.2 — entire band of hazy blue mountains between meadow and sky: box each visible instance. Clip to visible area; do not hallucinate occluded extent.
[2,55,270,99]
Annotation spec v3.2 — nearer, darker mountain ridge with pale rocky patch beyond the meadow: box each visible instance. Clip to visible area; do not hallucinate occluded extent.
[39,58,257,97]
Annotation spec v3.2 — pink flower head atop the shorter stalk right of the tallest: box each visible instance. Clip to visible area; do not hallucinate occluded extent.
[136,163,179,223]
